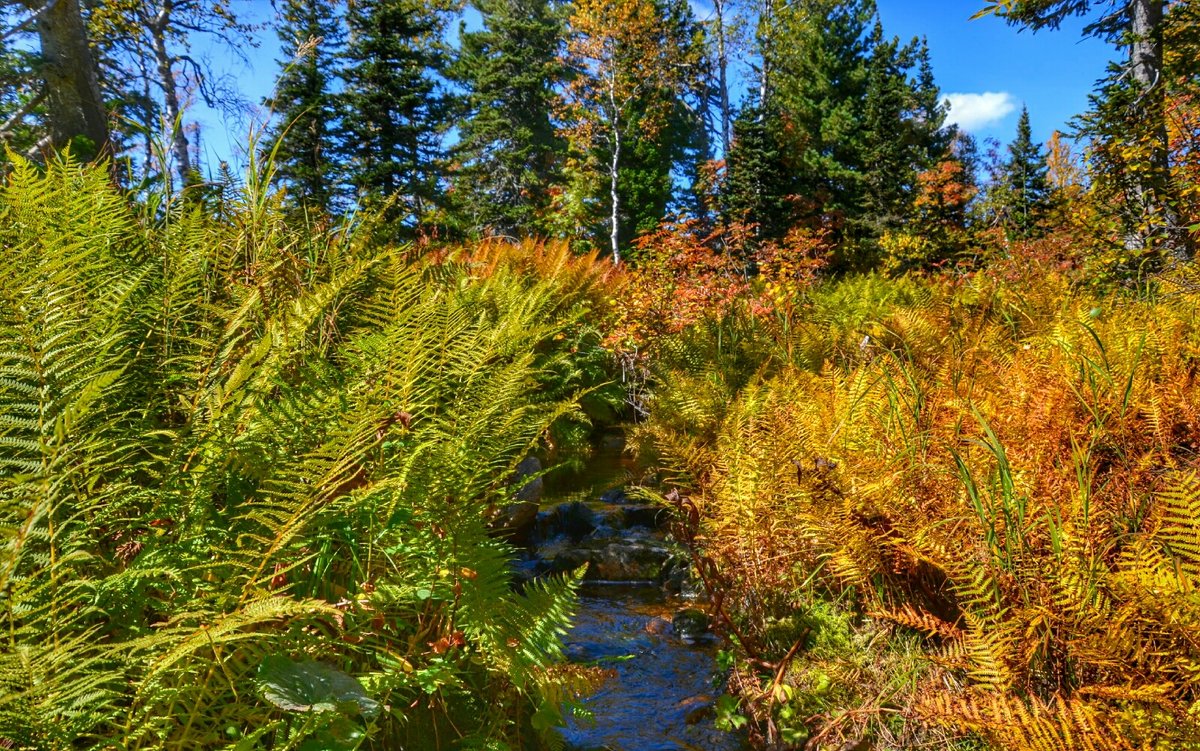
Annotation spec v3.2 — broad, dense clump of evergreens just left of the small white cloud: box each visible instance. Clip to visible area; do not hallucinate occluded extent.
[753,0,948,268]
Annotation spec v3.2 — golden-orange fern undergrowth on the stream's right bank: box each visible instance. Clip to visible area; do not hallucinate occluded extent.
[638,261,1200,751]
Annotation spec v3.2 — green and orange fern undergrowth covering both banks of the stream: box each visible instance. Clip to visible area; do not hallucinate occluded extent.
[9,152,1200,751]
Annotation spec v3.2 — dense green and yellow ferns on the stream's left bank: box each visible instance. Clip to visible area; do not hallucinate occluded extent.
[0,158,619,749]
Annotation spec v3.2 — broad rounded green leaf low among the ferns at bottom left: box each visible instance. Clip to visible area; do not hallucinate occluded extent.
[258,655,379,717]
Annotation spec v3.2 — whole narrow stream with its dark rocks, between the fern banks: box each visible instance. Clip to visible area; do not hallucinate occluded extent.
[529,441,749,751]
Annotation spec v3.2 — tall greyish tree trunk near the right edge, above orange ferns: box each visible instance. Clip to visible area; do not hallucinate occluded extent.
[1127,0,1192,260]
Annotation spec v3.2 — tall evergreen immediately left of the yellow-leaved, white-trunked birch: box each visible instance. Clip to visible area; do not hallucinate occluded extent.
[451,0,565,235]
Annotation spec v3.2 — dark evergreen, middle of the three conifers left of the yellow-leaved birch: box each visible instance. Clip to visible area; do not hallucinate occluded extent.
[343,0,452,226]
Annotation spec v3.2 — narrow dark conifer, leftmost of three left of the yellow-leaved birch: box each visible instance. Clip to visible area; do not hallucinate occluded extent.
[265,0,344,211]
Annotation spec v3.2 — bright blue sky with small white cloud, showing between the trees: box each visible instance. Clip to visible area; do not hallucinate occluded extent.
[192,0,1117,172]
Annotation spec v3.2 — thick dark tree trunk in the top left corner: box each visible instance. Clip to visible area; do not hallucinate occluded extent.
[24,0,109,160]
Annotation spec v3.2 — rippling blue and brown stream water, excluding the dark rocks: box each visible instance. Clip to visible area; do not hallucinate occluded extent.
[541,444,749,751]
